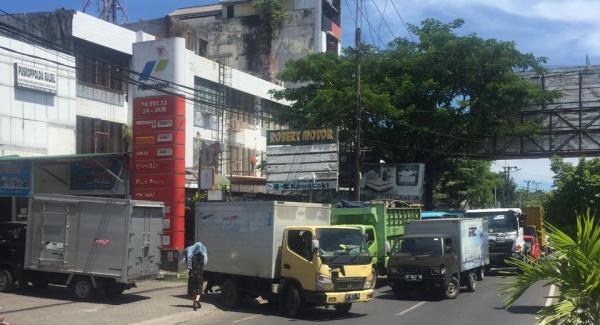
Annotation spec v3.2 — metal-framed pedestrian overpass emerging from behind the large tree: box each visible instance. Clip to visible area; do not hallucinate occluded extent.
[468,65,600,160]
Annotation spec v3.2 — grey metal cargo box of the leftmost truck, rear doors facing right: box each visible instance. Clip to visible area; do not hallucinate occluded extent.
[25,195,163,283]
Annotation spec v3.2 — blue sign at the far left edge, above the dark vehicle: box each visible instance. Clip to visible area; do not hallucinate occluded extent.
[0,162,31,197]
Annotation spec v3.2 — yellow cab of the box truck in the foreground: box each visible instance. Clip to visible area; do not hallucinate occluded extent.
[281,226,374,315]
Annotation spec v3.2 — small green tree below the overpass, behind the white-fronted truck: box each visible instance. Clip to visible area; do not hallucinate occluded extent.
[435,159,504,208]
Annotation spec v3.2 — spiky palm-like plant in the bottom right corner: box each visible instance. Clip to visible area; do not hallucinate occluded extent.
[502,211,600,324]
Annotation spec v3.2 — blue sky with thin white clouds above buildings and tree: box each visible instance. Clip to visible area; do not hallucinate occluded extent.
[0,0,600,190]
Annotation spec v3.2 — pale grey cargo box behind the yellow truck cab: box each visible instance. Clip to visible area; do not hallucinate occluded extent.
[195,201,331,279]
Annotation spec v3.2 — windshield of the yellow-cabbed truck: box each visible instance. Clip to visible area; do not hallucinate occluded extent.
[317,229,371,264]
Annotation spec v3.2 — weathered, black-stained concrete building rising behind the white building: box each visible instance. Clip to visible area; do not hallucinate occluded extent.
[125,0,342,82]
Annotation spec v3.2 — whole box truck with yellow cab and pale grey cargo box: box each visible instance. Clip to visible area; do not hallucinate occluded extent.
[195,201,373,317]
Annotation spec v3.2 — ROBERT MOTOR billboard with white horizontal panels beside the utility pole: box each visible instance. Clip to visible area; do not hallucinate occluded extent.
[266,128,339,192]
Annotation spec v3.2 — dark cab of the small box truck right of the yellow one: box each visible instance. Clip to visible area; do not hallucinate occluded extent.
[388,234,460,298]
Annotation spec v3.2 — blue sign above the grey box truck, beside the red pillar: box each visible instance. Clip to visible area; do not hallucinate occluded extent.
[70,159,123,191]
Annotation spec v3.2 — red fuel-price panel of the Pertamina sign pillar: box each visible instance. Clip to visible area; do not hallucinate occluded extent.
[131,96,185,249]
